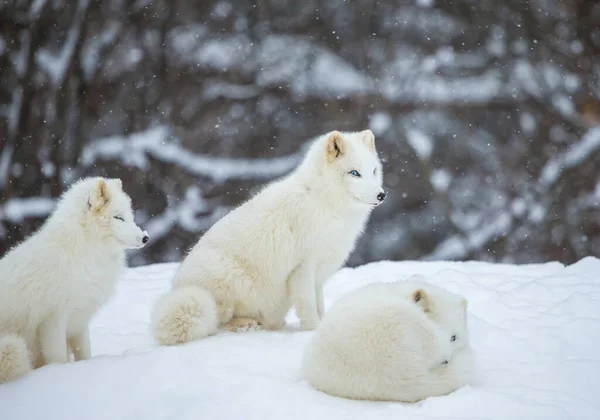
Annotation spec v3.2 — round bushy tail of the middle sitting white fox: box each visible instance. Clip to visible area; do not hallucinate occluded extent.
[152,286,218,345]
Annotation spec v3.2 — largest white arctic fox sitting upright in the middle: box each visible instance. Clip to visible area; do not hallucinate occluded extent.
[152,130,385,345]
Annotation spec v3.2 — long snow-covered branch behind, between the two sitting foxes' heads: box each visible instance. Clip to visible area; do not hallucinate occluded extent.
[80,126,305,183]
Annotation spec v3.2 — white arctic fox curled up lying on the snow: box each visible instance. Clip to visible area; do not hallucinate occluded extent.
[301,276,473,402]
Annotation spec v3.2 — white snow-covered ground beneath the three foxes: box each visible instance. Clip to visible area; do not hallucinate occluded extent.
[0,258,600,420]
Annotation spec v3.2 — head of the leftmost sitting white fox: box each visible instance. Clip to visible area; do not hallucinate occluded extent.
[83,178,149,248]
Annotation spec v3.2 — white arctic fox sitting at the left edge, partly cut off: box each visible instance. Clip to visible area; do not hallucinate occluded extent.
[0,178,149,383]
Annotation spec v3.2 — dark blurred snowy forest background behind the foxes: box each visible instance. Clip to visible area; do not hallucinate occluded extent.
[0,0,600,265]
